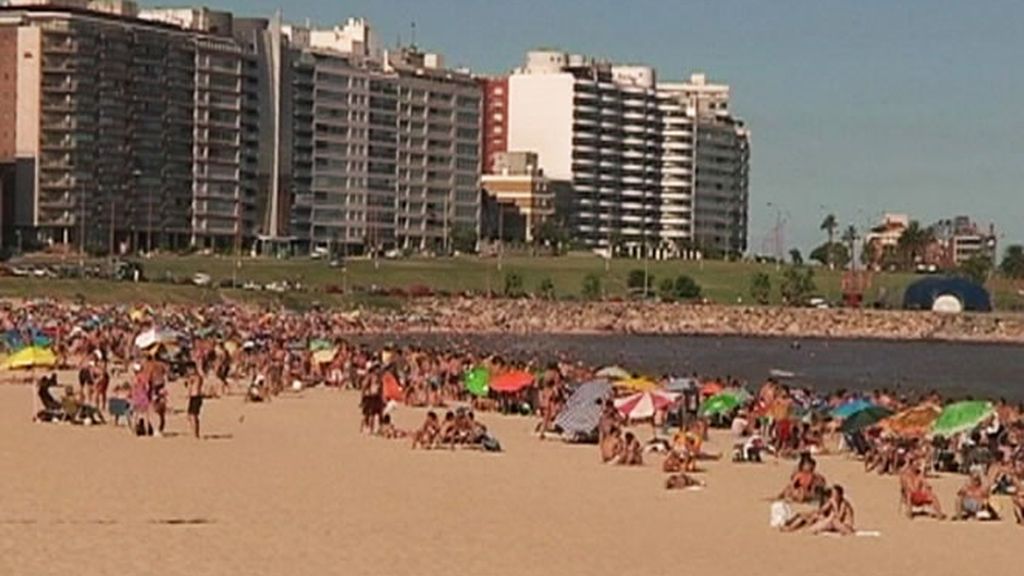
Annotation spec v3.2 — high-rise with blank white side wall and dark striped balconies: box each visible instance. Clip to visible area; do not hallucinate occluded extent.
[508,51,662,253]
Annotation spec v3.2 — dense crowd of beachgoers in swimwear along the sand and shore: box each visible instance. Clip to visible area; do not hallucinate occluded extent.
[6,295,1024,534]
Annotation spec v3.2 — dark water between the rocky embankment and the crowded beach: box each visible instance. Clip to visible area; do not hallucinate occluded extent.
[356,334,1024,402]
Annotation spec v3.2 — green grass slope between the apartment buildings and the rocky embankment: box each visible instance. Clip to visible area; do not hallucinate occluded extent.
[8,254,1022,310]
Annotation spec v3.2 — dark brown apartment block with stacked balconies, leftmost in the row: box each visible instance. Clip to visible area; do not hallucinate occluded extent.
[0,0,196,250]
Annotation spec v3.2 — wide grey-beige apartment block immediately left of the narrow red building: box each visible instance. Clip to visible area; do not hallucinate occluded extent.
[283,18,481,253]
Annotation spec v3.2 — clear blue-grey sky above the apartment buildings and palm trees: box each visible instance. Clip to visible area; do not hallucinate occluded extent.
[220,0,1024,251]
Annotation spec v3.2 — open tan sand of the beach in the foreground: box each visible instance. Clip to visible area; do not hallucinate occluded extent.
[0,377,1024,576]
